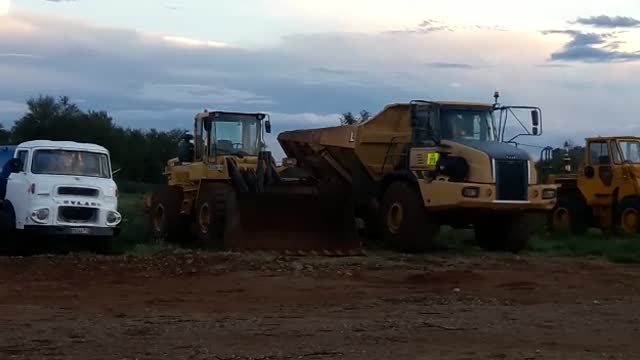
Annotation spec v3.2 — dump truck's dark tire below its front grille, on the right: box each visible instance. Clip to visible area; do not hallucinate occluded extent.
[474,214,531,254]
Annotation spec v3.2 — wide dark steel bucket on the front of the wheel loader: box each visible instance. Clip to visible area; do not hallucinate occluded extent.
[225,187,364,256]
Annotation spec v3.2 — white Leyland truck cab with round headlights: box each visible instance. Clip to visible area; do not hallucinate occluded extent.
[3,140,122,237]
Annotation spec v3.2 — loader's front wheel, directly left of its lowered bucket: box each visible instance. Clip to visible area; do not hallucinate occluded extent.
[195,183,233,250]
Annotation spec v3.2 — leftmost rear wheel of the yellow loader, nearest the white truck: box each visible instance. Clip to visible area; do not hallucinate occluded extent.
[149,186,189,244]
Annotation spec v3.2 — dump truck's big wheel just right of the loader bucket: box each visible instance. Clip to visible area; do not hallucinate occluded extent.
[380,182,440,252]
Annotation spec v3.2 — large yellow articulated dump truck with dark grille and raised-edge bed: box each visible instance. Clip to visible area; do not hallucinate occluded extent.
[278,95,557,252]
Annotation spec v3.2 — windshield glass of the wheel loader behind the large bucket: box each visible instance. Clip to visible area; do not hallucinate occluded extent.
[211,113,261,155]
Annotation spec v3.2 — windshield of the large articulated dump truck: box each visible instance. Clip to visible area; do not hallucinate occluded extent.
[440,108,497,141]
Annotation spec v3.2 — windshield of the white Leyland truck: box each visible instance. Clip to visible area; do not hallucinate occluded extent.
[31,149,111,178]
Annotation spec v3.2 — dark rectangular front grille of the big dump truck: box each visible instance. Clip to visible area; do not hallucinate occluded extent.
[496,160,529,201]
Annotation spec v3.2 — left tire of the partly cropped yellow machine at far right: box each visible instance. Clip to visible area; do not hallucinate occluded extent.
[548,194,589,235]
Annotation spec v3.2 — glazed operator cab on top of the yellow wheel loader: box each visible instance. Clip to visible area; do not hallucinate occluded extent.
[194,110,271,161]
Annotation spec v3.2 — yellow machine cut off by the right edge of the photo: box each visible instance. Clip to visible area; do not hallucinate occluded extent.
[547,136,640,234]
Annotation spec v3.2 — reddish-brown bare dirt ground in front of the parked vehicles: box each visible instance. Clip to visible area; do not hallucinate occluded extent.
[0,250,640,360]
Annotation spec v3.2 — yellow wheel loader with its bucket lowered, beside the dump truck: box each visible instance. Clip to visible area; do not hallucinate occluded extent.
[146,110,362,255]
